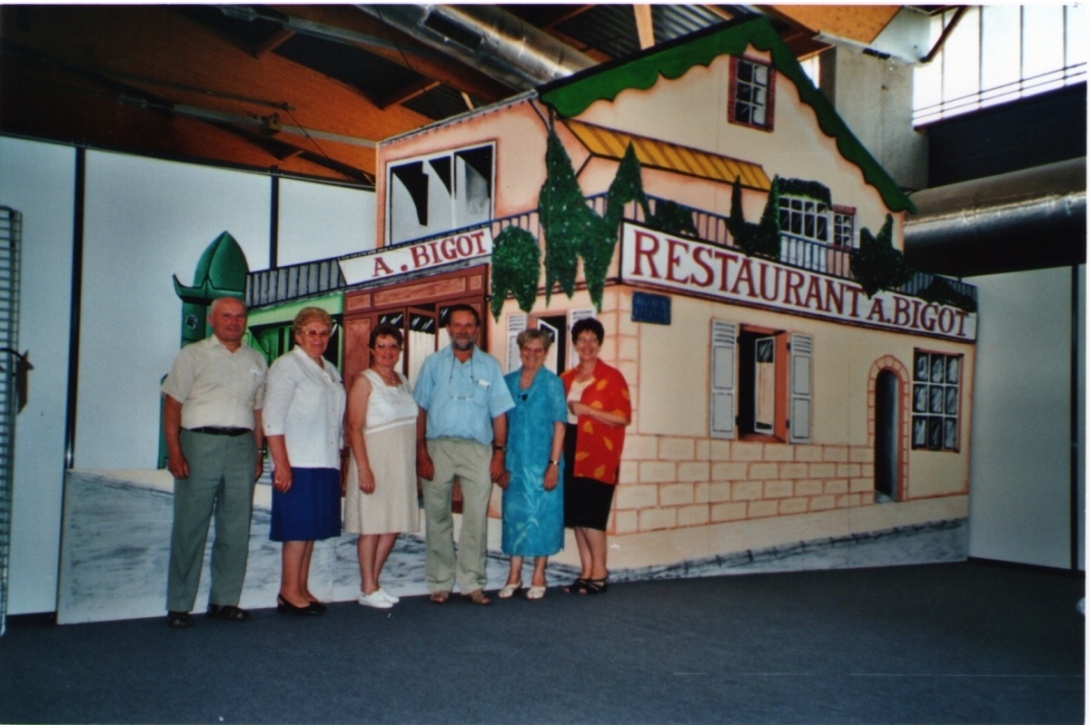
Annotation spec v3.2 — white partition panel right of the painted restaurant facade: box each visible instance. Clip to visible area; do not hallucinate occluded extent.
[969,268,1086,568]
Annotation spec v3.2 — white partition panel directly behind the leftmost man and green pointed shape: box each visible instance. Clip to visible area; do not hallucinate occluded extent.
[74,153,270,470]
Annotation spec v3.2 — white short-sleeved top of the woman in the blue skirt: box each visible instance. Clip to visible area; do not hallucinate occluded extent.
[262,346,347,469]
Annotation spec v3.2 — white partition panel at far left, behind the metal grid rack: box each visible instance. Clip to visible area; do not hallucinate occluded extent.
[0,136,75,616]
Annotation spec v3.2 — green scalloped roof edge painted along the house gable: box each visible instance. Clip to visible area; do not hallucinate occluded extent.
[537,17,916,213]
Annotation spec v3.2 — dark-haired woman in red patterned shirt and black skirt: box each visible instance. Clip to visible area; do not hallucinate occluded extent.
[560,318,632,595]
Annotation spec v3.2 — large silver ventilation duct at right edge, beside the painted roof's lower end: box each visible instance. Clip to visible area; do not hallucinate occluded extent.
[905,157,1087,277]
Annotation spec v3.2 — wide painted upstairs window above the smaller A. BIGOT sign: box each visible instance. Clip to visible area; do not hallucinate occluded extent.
[386,144,495,244]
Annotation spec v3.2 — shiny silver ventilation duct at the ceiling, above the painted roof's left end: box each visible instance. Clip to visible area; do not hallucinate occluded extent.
[356,4,597,90]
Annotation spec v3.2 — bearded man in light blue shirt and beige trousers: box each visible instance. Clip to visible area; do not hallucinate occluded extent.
[414,304,514,606]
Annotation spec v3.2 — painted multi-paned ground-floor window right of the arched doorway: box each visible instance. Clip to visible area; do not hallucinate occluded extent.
[912,350,961,452]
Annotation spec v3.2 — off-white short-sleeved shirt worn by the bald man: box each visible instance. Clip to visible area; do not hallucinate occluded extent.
[161,336,268,429]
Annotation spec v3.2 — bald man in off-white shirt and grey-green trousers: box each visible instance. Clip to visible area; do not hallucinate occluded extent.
[162,298,268,628]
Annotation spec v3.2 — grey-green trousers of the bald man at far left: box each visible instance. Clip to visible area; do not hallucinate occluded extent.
[167,429,257,611]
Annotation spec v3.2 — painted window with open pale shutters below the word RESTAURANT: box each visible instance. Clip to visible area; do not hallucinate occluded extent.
[709,320,813,443]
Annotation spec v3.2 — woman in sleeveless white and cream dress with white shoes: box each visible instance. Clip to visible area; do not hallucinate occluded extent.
[344,324,420,608]
